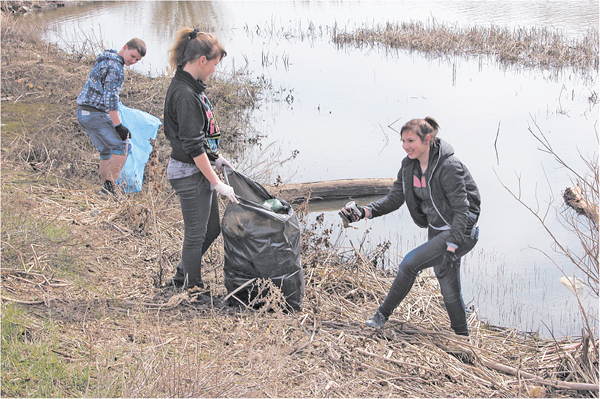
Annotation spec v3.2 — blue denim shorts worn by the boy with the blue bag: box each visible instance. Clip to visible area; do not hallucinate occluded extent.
[77,109,131,160]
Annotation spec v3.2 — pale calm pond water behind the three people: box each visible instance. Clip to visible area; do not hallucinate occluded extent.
[35,0,598,336]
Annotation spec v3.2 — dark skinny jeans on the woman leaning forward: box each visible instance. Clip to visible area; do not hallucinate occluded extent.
[379,227,479,335]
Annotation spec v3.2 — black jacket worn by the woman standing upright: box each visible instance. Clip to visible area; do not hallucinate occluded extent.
[164,68,208,163]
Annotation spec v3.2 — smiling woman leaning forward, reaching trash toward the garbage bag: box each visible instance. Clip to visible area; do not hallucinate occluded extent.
[340,117,481,336]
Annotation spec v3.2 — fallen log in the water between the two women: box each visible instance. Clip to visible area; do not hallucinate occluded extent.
[269,178,396,203]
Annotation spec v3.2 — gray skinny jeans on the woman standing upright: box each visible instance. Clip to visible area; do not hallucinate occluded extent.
[169,173,221,288]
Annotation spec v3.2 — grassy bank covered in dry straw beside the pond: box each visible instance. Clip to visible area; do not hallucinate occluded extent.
[0,10,598,397]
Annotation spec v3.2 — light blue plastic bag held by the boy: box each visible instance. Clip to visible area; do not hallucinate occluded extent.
[116,103,162,193]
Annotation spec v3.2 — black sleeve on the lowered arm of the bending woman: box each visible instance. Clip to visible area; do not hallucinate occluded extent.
[440,159,469,247]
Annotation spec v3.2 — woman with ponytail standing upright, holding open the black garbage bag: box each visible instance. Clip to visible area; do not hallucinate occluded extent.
[164,28,238,291]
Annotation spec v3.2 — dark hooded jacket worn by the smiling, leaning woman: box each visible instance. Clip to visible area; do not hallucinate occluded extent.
[366,139,481,246]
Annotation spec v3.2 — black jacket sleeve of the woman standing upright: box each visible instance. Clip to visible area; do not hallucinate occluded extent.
[176,99,206,158]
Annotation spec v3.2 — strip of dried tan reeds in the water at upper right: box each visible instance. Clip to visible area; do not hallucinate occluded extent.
[332,22,598,71]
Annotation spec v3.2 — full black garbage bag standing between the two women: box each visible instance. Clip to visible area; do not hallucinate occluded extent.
[221,168,304,310]
